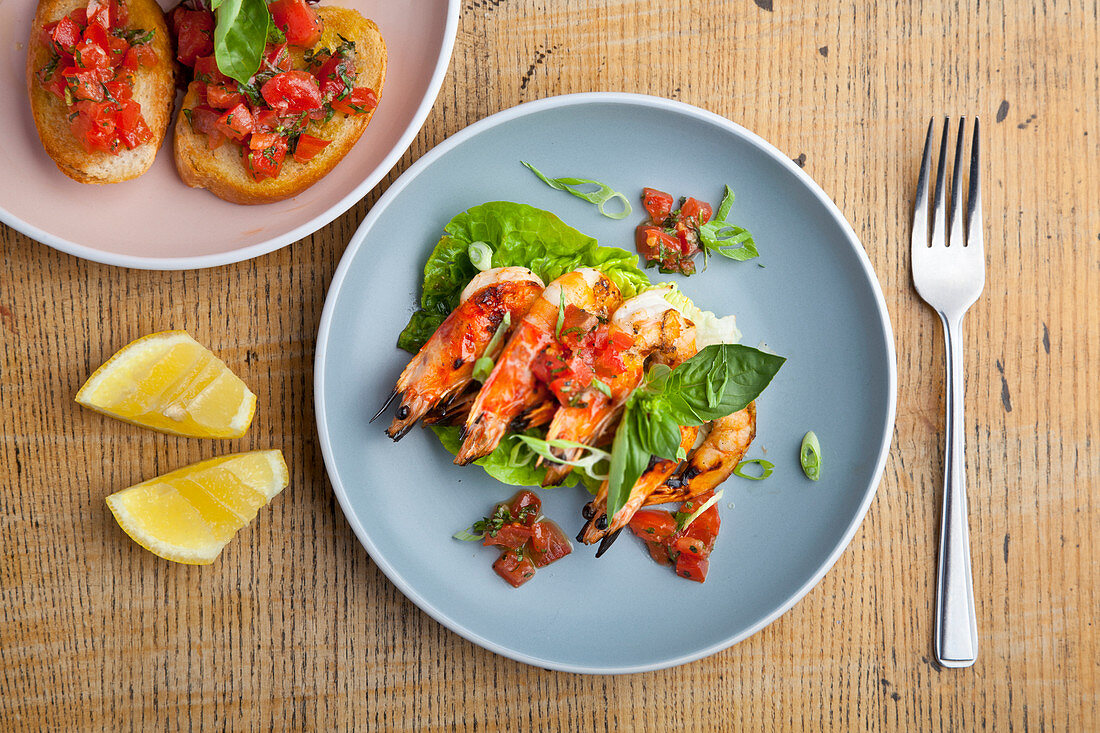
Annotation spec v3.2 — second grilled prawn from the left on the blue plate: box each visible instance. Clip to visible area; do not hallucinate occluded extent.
[454,267,622,466]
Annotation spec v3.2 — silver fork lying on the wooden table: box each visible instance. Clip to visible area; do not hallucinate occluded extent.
[913,118,986,667]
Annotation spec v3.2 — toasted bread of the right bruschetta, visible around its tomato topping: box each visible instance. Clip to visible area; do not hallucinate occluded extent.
[176,7,386,204]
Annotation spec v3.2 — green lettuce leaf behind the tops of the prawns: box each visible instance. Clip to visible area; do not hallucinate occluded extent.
[397,201,649,353]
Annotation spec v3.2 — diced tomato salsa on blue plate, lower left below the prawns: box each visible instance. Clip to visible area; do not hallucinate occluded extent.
[472,489,573,588]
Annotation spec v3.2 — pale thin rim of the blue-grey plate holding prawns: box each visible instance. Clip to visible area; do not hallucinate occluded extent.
[314,91,898,675]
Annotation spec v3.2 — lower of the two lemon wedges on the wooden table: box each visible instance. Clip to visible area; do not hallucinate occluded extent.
[107,450,289,565]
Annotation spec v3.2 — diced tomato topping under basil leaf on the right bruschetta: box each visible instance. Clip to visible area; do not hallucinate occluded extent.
[171,0,378,182]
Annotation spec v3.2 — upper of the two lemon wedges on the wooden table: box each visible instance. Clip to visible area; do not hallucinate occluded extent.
[76,331,256,438]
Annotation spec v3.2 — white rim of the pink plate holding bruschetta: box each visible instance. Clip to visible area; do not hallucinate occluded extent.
[0,0,461,271]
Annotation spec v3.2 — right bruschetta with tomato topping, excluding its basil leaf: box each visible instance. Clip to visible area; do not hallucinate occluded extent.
[173,0,386,204]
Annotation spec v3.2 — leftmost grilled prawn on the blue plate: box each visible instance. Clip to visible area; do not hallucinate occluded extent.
[375,267,543,440]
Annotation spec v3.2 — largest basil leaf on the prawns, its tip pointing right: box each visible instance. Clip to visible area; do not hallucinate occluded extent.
[663,343,787,426]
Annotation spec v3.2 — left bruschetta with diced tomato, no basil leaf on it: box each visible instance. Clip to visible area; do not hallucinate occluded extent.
[26,0,176,184]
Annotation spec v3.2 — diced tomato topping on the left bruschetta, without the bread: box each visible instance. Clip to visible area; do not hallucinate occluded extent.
[37,0,157,155]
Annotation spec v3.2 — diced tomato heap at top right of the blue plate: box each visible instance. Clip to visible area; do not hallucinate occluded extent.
[635,188,714,275]
